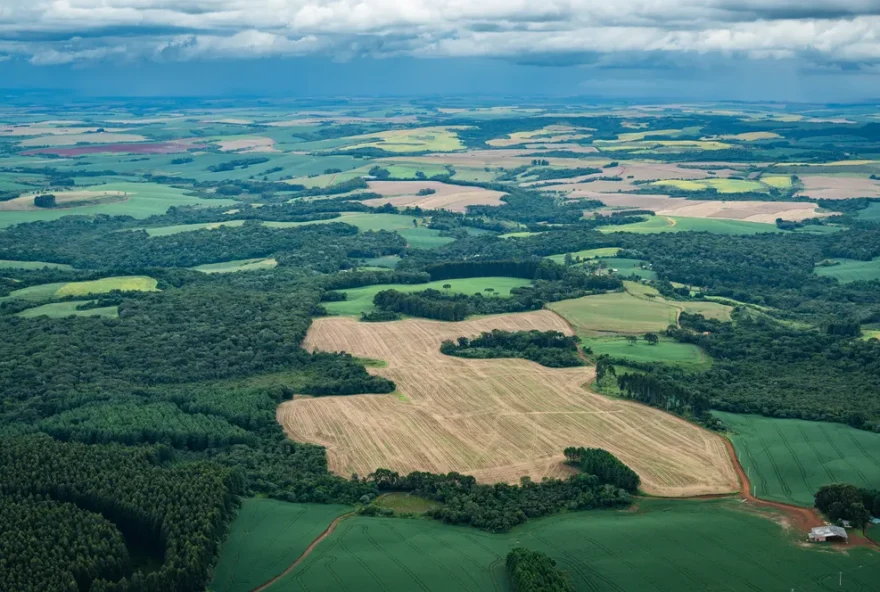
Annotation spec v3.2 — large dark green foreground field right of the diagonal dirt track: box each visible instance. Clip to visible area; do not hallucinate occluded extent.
[269,500,880,592]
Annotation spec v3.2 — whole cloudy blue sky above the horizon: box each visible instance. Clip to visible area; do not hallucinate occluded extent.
[0,0,880,102]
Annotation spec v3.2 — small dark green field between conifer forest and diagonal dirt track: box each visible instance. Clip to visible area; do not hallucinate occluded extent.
[210,498,351,592]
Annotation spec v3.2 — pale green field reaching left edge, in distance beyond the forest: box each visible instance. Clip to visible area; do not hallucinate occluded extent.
[0,183,235,228]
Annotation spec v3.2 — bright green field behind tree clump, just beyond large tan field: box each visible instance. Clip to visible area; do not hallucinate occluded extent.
[324,277,531,315]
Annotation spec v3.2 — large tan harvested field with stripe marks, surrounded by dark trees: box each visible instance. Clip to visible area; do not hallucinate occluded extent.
[277,310,738,496]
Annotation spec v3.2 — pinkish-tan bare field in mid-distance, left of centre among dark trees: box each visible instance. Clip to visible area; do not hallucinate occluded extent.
[363,181,504,212]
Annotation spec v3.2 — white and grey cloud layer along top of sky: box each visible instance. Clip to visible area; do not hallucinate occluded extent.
[0,0,880,66]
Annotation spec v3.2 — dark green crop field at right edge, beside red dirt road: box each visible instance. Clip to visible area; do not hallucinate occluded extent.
[716,412,880,506]
